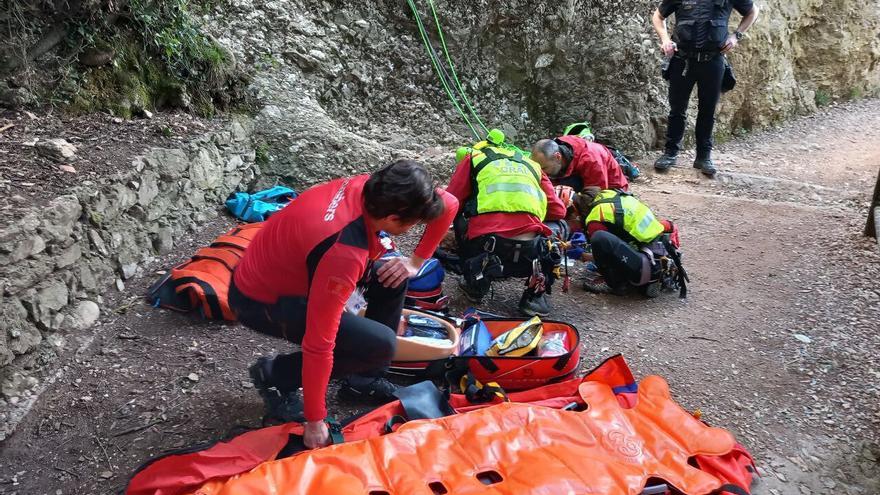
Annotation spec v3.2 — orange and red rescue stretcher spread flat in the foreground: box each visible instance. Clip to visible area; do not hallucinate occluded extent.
[126,356,754,495]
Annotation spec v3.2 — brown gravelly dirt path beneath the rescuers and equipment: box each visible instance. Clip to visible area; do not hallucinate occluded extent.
[0,101,880,495]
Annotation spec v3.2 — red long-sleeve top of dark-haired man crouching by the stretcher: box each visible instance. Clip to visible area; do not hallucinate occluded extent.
[235,175,458,421]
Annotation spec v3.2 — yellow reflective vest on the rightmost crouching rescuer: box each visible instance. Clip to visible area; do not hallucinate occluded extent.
[584,189,666,244]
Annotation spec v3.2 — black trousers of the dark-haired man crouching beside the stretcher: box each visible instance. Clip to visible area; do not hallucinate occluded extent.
[229,276,407,392]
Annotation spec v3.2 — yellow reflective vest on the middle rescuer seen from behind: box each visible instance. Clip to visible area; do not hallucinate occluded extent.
[466,146,547,220]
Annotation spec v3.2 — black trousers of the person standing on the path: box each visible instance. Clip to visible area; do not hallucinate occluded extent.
[666,54,724,158]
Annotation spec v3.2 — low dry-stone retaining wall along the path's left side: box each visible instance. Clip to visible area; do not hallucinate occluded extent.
[0,121,259,440]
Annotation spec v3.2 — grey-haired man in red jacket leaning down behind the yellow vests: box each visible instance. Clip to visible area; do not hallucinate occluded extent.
[532,135,629,202]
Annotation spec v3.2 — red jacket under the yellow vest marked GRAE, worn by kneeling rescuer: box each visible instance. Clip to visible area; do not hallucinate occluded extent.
[446,156,565,239]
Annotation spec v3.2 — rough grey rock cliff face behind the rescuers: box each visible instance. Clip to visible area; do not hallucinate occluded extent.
[205,0,880,184]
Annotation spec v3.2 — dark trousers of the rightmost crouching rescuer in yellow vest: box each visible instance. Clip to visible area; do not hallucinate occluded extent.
[590,230,651,289]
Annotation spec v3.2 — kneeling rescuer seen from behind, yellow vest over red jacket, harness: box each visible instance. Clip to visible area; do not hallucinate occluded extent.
[446,142,567,316]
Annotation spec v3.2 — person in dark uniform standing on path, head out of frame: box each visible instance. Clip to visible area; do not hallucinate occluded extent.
[653,0,758,177]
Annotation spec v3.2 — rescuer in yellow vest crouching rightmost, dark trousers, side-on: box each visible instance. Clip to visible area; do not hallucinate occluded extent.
[584,190,679,297]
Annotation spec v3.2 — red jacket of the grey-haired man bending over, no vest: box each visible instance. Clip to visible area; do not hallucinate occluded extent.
[551,136,629,191]
